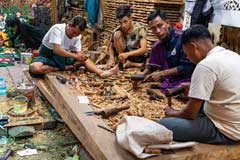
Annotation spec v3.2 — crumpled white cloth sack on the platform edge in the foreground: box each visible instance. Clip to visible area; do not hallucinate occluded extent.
[116,116,173,158]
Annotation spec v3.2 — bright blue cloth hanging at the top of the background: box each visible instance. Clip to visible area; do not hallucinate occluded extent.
[84,0,99,27]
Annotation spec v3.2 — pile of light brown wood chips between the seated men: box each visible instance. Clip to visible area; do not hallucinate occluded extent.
[62,70,184,128]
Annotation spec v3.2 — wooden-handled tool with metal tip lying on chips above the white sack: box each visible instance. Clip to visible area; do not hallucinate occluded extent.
[85,106,130,118]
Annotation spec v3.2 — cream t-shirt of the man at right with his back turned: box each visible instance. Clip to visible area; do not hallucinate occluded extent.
[189,46,240,140]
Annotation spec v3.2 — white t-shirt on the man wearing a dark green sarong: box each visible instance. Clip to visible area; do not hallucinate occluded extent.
[42,23,81,51]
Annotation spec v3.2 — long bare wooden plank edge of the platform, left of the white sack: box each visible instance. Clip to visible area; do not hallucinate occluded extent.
[36,75,137,160]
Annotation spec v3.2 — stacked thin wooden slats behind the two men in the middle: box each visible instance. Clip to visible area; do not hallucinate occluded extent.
[100,0,183,49]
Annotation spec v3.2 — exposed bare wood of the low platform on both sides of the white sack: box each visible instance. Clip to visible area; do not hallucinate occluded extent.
[33,71,240,160]
